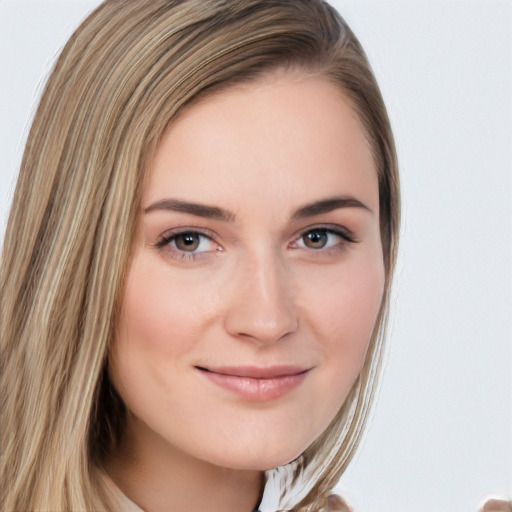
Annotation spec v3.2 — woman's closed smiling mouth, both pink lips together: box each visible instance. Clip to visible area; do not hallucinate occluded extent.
[195,366,312,402]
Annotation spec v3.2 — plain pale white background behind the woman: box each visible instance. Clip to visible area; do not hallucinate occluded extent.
[0,0,512,512]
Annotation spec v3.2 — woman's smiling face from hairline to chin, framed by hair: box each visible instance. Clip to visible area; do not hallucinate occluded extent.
[109,76,384,470]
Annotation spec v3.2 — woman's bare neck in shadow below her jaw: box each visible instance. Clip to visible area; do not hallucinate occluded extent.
[106,418,263,512]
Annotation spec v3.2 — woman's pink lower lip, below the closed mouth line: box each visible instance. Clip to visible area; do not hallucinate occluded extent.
[198,369,309,402]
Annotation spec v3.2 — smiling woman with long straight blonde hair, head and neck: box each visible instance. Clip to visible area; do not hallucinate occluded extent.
[1,0,399,512]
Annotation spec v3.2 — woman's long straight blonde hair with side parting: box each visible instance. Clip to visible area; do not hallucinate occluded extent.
[0,0,399,512]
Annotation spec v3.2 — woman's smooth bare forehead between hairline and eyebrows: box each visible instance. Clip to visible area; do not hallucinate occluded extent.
[143,75,378,216]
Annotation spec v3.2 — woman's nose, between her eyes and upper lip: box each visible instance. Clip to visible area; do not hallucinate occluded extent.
[225,251,298,345]
